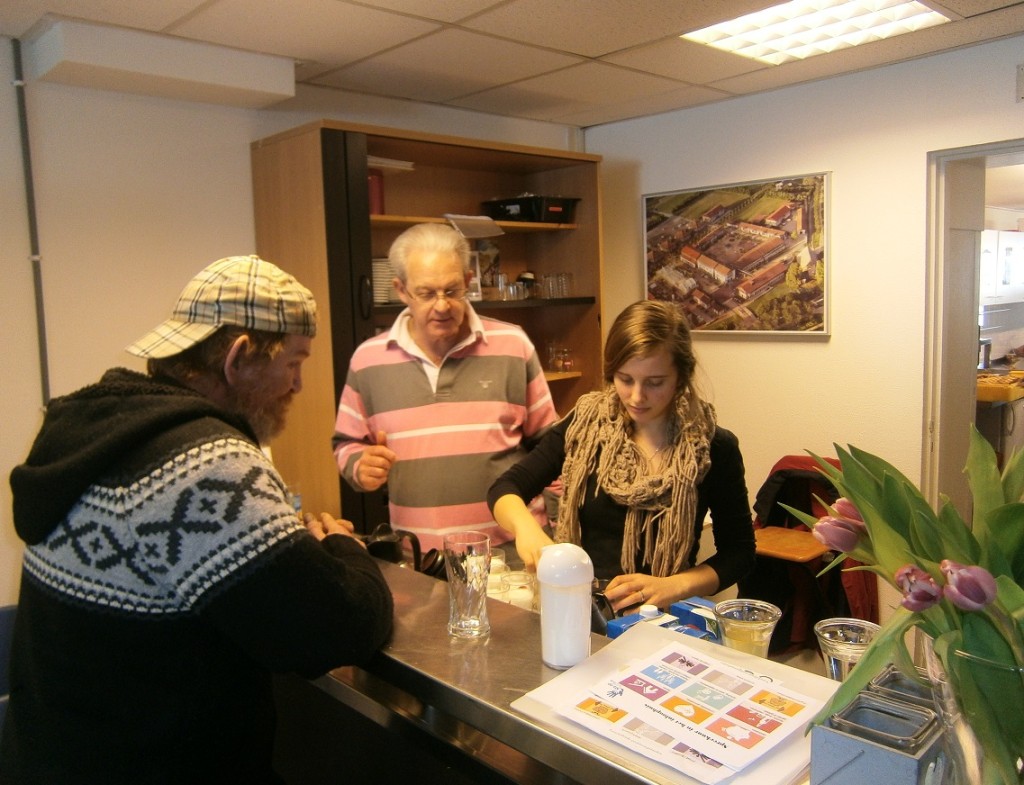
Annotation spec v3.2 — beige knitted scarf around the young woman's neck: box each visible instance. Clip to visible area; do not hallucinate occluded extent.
[555,387,715,577]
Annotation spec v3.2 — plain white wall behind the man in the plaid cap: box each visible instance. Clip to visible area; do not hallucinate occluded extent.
[0,38,578,605]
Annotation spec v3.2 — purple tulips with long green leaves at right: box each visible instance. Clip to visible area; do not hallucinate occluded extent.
[790,428,1024,785]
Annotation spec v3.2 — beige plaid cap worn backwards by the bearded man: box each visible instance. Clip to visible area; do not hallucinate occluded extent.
[125,256,316,357]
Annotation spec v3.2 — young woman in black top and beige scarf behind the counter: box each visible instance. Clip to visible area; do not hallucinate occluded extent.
[487,301,755,611]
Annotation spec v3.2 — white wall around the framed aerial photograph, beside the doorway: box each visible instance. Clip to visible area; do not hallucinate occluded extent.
[586,37,1024,532]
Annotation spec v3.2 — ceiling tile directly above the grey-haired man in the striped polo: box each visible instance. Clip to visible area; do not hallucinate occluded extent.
[313,29,582,101]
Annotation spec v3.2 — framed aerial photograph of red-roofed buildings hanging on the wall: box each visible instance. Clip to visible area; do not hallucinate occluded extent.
[643,173,828,336]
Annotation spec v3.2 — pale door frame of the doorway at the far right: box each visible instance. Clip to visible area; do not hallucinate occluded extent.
[922,139,1024,520]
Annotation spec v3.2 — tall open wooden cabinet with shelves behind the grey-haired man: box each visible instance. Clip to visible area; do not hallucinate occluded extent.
[252,121,601,529]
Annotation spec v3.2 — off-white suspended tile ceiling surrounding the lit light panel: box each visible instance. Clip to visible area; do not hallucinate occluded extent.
[6,0,1024,122]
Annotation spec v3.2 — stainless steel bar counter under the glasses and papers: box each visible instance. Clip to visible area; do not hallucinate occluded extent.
[315,563,819,785]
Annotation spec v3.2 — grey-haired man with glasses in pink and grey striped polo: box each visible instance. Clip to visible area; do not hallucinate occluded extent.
[334,224,557,549]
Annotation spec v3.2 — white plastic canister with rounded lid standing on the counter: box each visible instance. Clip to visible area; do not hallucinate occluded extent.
[537,542,594,670]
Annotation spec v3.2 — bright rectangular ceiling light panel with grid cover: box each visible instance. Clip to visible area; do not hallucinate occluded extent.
[680,0,949,66]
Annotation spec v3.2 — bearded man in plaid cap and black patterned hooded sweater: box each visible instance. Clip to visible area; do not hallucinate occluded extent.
[0,256,392,785]
